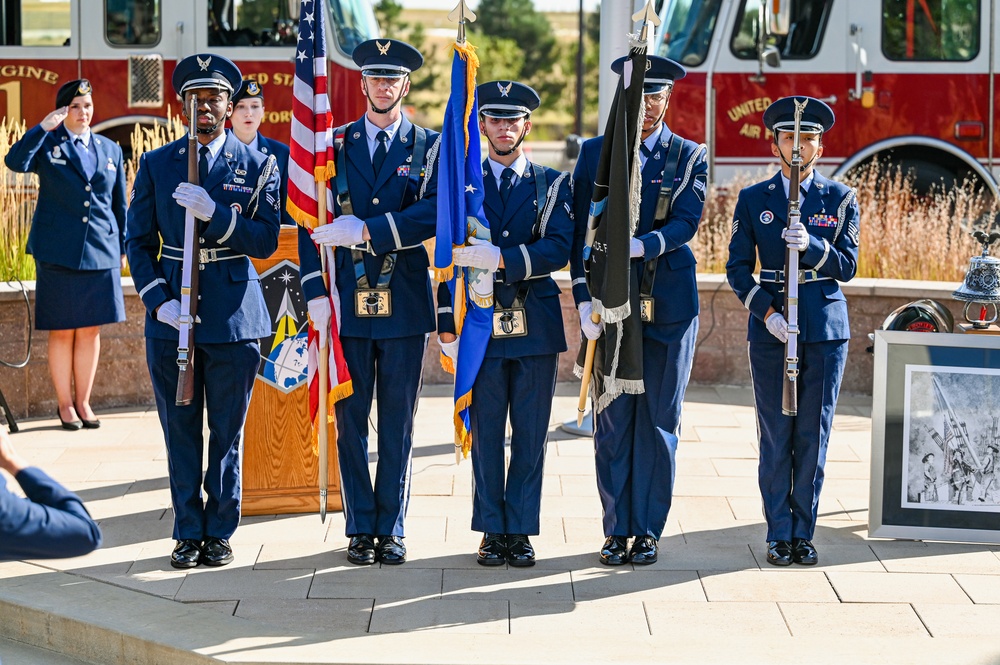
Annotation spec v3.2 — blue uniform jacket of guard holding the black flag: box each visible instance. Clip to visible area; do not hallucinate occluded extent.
[570,125,708,337]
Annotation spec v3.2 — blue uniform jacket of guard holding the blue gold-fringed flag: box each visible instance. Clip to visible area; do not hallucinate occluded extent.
[438,162,573,358]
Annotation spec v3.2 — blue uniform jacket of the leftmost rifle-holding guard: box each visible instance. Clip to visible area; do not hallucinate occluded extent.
[125,135,280,344]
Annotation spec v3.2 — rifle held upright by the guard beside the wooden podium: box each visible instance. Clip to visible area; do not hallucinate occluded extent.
[174,94,201,406]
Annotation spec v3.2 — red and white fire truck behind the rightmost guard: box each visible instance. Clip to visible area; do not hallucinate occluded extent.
[656,0,1000,195]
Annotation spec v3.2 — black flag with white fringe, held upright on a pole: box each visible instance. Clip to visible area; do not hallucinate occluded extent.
[577,42,646,413]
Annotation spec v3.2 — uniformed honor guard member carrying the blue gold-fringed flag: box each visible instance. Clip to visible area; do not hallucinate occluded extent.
[438,81,573,566]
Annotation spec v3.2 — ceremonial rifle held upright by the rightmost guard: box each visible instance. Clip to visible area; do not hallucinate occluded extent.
[781,99,809,416]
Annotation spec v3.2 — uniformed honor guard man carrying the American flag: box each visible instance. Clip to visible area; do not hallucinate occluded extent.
[299,39,438,565]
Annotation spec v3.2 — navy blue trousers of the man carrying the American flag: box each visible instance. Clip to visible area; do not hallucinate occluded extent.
[336,334,427,536]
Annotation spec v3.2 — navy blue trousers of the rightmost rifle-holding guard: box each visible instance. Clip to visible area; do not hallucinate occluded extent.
[749,339,847,540]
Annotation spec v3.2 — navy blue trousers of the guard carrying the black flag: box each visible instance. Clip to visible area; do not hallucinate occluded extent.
[594,318,698,539]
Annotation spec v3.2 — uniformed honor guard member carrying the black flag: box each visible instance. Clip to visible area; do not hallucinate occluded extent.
[570,56,708,566]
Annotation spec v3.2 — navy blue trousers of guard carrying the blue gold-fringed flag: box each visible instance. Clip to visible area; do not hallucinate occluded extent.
[470,354,559,536]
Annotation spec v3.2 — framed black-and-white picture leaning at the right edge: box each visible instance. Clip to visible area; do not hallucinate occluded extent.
[869,330,1000,543]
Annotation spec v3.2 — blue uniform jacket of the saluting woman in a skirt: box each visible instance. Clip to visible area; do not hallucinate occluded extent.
[4,125,125,270]
